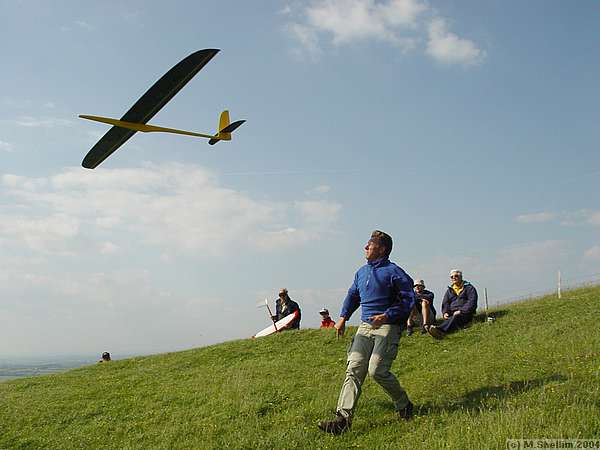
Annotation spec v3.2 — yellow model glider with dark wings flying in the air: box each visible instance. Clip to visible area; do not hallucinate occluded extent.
[79,49,245,169]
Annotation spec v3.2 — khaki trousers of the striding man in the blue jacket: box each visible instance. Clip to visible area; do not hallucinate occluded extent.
[337,322,408,418]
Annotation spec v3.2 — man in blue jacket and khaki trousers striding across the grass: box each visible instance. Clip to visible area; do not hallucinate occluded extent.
[318,230,414,434]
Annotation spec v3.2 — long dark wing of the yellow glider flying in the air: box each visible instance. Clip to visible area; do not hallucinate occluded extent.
[81,49,220,169]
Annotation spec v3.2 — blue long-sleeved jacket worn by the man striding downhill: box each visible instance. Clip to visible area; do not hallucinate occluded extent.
[340,258,414,323]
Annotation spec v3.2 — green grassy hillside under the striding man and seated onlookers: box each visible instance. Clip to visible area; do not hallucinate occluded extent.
[0,287,600,449]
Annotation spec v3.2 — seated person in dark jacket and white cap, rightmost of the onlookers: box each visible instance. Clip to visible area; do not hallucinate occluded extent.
[427,270,477,339]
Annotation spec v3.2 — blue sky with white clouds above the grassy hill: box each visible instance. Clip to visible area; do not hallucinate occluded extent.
[0,0,600,357]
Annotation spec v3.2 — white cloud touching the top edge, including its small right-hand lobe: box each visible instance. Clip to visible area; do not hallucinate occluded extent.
[287,0,484,64]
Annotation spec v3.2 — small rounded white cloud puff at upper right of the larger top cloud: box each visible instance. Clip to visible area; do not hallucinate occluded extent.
[427,17,485,65]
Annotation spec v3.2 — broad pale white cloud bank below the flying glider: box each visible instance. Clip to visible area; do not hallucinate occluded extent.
[0,164,341,257]
